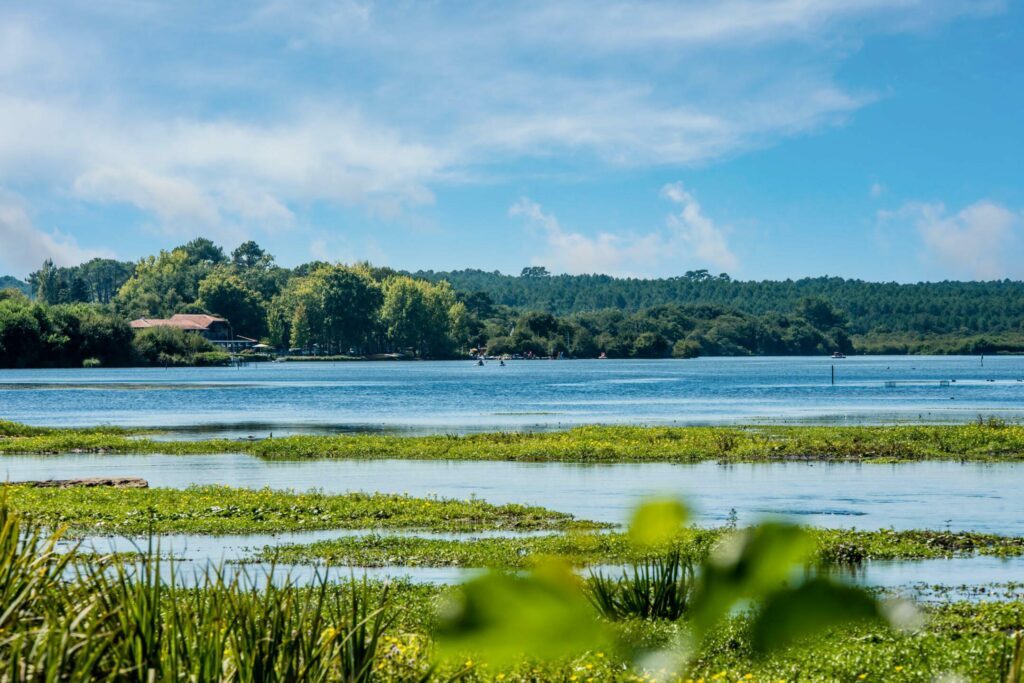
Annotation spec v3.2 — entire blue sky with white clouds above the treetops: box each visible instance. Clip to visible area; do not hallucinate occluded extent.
[0,0,1024,282]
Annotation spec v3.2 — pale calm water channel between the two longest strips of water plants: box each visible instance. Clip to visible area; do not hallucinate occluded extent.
[6,455,1024,535]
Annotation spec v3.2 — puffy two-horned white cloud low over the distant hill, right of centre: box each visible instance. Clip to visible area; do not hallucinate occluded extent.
[509,183,739,276]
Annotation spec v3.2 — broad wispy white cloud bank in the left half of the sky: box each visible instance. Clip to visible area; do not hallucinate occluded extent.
[0,96,440,234]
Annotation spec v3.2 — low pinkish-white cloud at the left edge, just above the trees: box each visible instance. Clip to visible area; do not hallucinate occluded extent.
[0,196,112,276]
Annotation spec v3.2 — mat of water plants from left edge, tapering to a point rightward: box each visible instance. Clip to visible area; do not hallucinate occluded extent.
[3,484,601,536]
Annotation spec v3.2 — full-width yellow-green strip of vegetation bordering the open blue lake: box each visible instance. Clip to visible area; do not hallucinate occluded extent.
[0,420,1024,463]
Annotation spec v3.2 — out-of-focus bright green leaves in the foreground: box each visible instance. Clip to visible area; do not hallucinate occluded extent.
[438,500,898,673]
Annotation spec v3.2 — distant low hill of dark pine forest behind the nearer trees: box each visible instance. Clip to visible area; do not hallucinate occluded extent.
[413,268,1024,335]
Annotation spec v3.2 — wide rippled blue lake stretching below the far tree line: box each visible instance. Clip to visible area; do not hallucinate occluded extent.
[0,356,1024,435]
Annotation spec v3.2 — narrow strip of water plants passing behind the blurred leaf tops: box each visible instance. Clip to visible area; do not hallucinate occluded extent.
[254,527,1024,568]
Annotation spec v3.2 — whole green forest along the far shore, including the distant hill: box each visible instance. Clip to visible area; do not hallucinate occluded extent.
[0,238,1024,367]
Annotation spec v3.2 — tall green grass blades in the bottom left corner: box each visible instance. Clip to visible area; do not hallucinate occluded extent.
[0,501,419,683]
